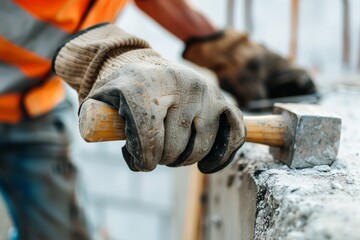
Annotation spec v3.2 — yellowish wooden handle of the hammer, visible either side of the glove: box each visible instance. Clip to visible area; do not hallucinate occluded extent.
[79,99,288,147]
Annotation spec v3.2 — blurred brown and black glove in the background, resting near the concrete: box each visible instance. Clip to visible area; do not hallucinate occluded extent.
[183,30,316,107]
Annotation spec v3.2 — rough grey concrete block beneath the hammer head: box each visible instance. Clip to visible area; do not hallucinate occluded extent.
[207,83,360,240]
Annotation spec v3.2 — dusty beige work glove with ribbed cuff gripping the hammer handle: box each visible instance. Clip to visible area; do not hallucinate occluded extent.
[53,24,245,173]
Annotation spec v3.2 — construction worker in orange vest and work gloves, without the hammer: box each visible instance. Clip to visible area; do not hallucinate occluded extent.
[0,0,316,239]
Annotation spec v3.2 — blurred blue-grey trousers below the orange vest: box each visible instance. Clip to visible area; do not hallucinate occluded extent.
[0,98,89,240]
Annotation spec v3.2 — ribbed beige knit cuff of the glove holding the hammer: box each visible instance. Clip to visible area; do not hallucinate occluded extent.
[52,24,150,102]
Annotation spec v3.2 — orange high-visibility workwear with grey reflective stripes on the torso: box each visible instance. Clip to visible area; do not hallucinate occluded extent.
[0,0,127,123]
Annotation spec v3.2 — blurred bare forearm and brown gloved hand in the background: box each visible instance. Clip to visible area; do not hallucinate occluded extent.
[136,0,316,106]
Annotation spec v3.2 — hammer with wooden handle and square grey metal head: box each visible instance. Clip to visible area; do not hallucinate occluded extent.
[79,99,341,168]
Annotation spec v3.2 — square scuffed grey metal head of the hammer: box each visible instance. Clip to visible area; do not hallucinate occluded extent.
[270,103,341,168]
